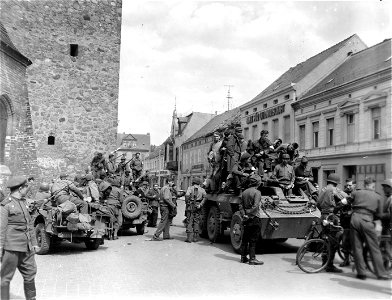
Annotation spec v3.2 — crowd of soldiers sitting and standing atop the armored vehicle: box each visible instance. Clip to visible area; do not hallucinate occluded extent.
[205,124,318,197]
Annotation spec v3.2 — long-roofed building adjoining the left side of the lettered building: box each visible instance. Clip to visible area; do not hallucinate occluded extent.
[179,108,241,189]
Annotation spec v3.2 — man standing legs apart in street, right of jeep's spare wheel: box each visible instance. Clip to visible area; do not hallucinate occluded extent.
[151,178,176,241]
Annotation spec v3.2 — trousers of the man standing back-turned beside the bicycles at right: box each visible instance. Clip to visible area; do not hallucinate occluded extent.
[350,212,386,276]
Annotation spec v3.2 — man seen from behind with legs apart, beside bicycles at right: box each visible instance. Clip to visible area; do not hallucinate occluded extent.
[341,177,391,280]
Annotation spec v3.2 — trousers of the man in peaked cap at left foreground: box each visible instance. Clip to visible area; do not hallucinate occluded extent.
[1,250,37,300]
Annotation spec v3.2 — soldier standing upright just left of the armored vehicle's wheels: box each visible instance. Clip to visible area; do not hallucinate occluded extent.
[185,177,207,243]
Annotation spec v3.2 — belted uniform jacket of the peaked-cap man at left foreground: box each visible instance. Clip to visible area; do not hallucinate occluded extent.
[0,196,37,252]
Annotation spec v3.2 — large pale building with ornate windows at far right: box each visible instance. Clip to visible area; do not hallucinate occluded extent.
[293,39,392,191]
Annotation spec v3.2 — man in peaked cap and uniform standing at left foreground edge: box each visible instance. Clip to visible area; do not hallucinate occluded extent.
[0,176,38,300]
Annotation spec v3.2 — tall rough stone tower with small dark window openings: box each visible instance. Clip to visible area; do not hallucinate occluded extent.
[1,0,122,179]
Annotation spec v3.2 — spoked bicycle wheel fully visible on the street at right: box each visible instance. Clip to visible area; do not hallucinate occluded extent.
[296,239,331,273]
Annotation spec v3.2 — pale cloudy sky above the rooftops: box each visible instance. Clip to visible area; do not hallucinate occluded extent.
[118,0,392,145]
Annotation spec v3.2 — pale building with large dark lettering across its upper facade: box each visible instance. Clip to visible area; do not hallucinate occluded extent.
[240,35,366,143]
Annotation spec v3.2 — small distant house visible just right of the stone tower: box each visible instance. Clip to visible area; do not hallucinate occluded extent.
[117,133,150,161]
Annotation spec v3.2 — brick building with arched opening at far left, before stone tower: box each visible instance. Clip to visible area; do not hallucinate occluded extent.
[0,22,39,188]
